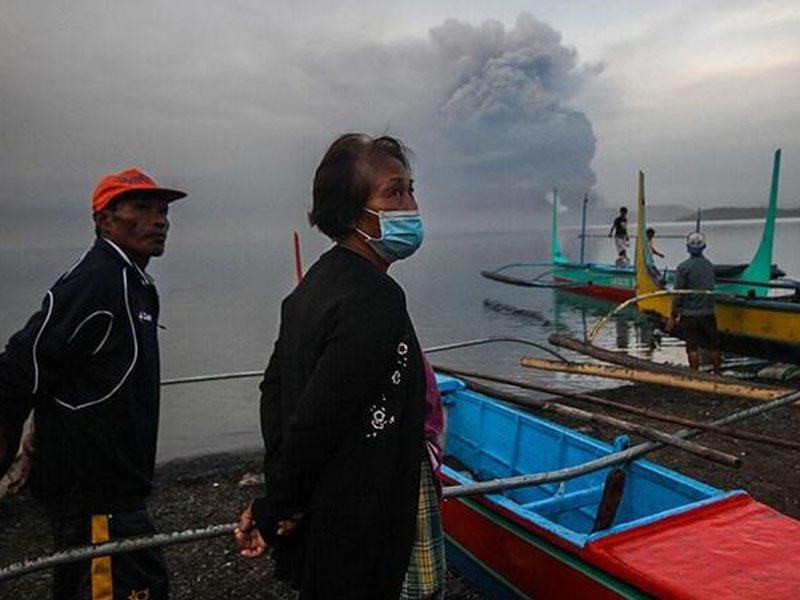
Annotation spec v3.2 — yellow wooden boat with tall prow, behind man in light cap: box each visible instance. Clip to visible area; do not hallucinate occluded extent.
[634,166,800,363]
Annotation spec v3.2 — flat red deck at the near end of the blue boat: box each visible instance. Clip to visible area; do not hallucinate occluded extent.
[584,494,800,600]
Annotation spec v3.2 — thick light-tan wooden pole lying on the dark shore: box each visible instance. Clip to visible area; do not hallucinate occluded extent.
[519,356,790,400]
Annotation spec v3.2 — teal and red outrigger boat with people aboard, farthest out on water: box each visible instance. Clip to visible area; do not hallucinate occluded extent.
[481,150,793,302]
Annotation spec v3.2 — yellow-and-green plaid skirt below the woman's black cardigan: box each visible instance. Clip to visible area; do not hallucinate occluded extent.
[400,457,445,600]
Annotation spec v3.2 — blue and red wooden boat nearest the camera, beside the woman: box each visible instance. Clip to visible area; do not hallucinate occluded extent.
[437,376,800,600]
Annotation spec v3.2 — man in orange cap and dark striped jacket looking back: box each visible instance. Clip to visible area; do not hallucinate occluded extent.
[0,169,186,600]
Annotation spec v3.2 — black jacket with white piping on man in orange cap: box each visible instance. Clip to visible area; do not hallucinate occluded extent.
[0,239,159,516]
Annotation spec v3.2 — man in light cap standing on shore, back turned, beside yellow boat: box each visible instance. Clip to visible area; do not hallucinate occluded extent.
[666,231,722,374]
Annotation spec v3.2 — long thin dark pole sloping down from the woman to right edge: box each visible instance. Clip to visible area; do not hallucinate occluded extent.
[434,366,800,450]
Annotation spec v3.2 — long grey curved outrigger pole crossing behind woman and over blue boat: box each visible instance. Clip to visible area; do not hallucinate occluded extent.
[0,391,800,581]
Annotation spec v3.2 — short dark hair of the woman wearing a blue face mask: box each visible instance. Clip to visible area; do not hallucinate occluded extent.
[308,133,411,240]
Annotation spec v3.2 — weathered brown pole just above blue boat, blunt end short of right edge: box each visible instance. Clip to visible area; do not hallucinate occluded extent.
[467,380,742,467]
